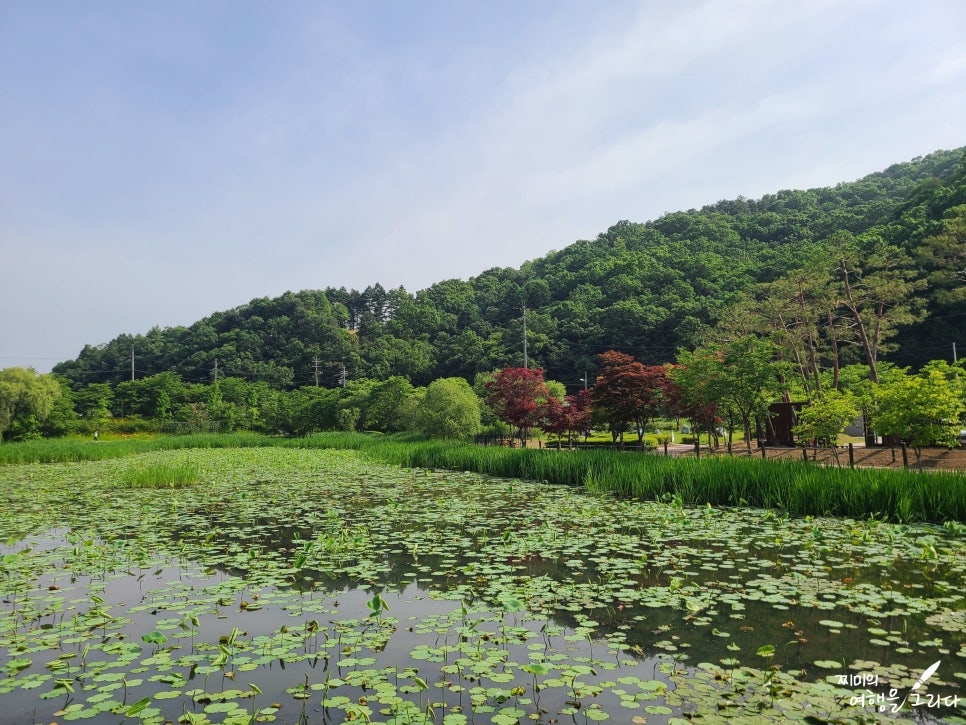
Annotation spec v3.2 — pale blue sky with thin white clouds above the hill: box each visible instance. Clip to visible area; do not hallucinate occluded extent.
[0,0,966,372]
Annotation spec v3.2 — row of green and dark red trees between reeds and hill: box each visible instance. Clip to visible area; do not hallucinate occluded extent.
[0,346,966,470]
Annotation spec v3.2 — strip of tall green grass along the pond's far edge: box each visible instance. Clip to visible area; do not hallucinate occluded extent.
[0,433,966,523]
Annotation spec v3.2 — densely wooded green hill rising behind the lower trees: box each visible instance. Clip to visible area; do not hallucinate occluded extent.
[54,149,966,388]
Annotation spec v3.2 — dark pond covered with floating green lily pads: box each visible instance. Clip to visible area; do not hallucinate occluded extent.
[0,448,966,725]
